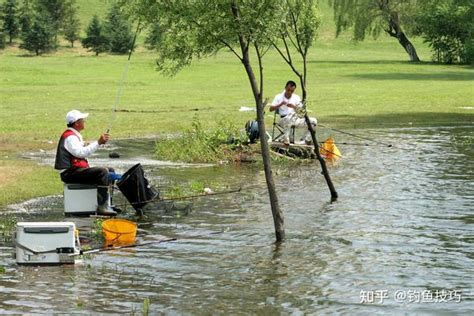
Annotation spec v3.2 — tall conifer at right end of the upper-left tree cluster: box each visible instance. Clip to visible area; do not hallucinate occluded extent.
[104,4,133,54]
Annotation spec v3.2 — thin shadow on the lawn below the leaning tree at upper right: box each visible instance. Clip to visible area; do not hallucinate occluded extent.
[348,72,474,81]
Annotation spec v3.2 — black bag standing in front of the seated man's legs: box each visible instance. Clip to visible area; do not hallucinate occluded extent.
[117,163,160,213]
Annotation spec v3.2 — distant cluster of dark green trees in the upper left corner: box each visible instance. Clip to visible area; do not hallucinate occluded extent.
[0,0,141,55]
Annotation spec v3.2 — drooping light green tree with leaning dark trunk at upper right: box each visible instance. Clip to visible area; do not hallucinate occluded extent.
[331,0,420,62]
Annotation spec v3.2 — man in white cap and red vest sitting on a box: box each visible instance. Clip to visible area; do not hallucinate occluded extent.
[54,110,117,215]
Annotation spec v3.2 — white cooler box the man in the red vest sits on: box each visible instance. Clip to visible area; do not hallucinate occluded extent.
[64,183,97,215]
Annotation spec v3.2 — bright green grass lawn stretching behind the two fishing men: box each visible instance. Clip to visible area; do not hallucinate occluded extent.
[0,1,474,205]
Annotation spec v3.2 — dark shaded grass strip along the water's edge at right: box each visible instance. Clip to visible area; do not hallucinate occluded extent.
[320,110,474,128]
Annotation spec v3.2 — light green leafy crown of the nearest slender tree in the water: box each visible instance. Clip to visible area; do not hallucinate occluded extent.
[121,0,282,75]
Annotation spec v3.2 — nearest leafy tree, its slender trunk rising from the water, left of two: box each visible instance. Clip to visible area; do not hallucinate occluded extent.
[122,0,285,241]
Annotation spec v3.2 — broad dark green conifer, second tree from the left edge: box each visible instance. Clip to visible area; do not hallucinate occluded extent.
[20,14,55,56]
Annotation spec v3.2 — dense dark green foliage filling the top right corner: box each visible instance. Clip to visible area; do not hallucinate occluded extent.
[417,0,474,64]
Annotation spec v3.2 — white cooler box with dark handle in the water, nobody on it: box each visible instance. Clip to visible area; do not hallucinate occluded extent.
[14,222,80,265]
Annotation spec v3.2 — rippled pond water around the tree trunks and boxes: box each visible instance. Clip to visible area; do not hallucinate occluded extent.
[0,126,474,315]
